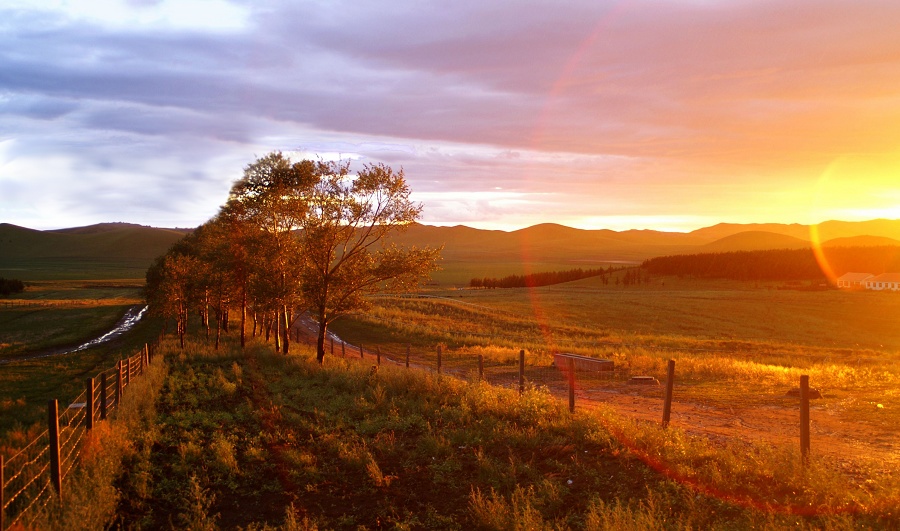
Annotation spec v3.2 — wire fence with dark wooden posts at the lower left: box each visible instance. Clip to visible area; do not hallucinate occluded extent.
[0,344,156,531]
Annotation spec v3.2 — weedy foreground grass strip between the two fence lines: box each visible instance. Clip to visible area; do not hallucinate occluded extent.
[47,340,900,530]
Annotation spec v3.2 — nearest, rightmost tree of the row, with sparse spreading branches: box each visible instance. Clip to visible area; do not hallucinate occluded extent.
[299,162,440,363]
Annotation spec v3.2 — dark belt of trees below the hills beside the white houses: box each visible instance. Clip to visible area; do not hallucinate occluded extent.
[641,246,900,281]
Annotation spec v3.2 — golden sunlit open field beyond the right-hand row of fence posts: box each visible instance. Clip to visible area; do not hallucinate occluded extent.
[333,278,900,467]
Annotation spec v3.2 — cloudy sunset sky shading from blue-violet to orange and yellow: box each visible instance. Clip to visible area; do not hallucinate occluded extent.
[0,0,900,230]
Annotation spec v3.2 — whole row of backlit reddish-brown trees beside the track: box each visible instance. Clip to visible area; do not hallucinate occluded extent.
[146,152,440,363]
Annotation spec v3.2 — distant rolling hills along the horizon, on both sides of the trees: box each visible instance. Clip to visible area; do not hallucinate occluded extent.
[0,219,900,283]
